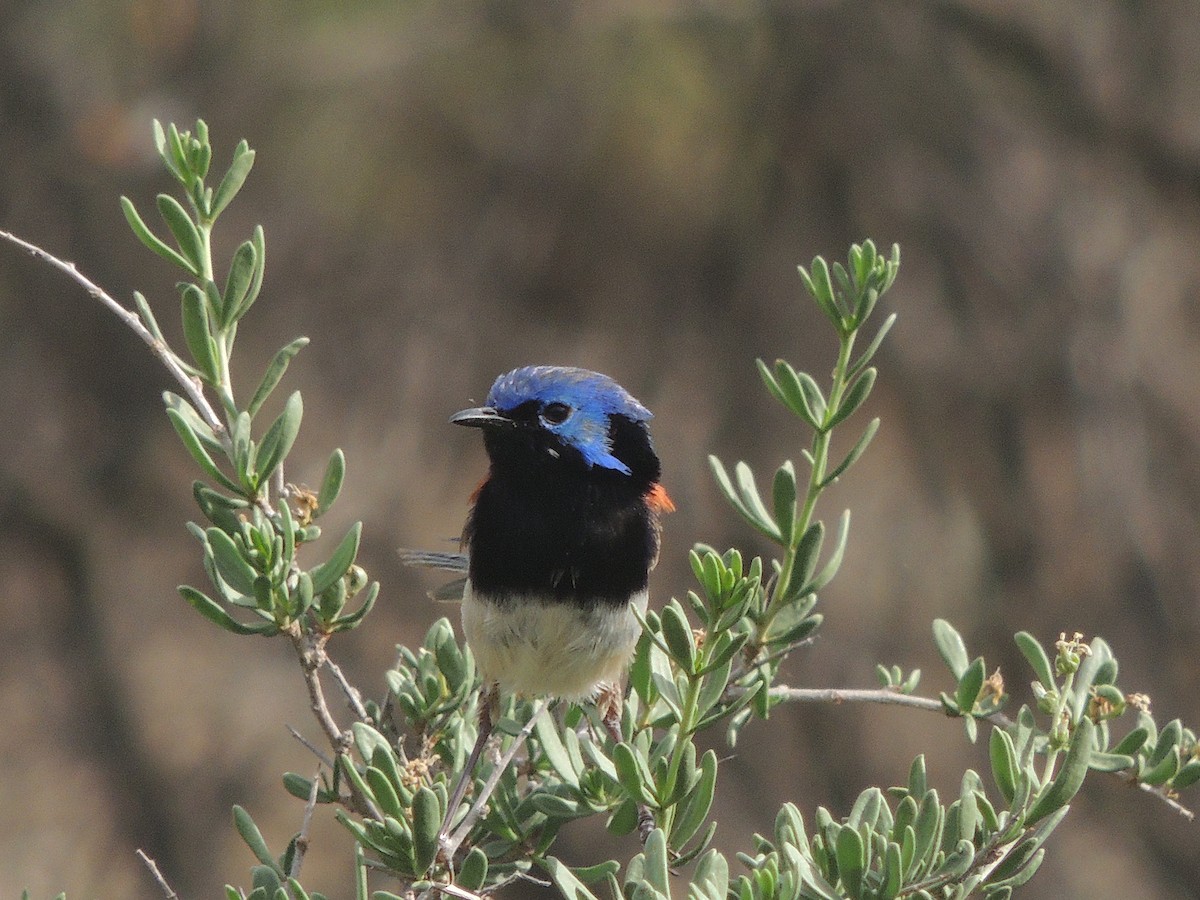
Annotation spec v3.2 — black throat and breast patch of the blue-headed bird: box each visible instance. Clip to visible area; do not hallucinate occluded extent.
[463,416,660,606]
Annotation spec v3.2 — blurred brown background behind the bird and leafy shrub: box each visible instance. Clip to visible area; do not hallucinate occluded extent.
[0,0,1200,899]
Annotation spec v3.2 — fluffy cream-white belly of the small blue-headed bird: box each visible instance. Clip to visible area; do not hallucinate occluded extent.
[462,581,647,700]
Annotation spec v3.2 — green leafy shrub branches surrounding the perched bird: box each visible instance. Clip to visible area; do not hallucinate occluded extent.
[6,122,1200,900]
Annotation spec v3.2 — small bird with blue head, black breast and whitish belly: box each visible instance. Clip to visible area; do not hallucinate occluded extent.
[422,365,674,854]
